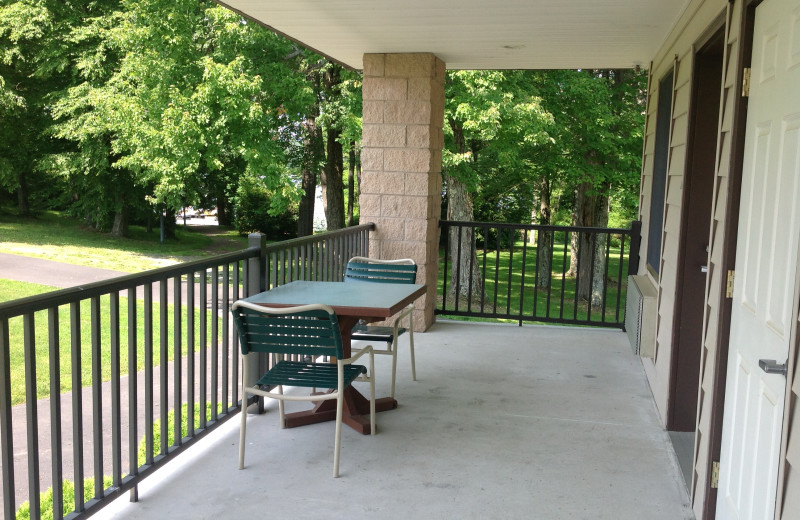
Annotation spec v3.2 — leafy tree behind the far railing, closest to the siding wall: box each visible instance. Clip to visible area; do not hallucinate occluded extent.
[538,70,646,303]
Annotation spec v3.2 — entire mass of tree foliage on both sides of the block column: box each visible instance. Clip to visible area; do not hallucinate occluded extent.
[0,0,644,251]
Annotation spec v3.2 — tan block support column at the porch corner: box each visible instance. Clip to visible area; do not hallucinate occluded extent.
[359,53,445,330]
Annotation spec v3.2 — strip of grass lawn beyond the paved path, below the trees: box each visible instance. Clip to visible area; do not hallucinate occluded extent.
[0,212,247,273]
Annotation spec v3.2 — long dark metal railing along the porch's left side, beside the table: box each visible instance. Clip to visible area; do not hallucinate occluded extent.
[0,224,374,520]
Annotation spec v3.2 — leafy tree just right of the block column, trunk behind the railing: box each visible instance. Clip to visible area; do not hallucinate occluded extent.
[443,71,552,296]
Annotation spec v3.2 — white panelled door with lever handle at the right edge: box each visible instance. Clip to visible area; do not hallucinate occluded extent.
[717,0,800,520]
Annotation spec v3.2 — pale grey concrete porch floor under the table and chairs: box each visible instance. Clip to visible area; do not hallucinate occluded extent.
[96,320,694,520]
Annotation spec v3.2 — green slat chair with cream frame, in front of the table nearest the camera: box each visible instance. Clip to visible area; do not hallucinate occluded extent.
[231,300,375,478]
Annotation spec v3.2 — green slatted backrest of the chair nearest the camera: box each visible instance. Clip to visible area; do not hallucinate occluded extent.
[231,302,344,359]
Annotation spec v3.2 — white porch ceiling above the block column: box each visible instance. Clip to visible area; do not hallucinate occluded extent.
[219,0,688,69]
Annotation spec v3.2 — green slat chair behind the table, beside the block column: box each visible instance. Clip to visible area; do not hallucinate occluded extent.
[344,256,417,398]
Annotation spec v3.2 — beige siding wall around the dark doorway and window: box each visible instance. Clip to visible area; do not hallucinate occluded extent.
[640,0,742,518]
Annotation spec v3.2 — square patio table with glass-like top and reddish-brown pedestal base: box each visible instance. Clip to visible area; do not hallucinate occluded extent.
[244,281,425,435]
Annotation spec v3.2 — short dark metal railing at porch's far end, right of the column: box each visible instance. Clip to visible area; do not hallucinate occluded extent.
[436,221,641,328]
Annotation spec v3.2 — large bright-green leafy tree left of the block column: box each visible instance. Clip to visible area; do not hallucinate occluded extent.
[47,0,311,237]
